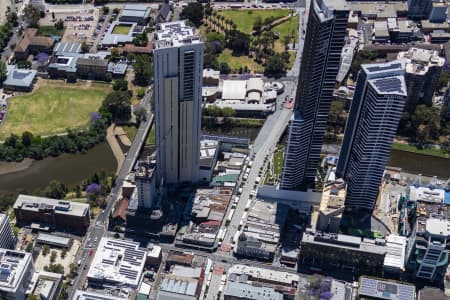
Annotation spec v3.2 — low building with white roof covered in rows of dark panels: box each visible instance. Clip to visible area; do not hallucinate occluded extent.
[87,237,147,289]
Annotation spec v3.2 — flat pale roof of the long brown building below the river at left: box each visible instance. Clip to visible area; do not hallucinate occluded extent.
[14,194,89,217]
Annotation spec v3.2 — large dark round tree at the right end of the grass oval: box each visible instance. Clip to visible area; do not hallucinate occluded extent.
[102,91,131,124]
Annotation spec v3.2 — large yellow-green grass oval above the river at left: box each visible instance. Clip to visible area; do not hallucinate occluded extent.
[0,80,110,139]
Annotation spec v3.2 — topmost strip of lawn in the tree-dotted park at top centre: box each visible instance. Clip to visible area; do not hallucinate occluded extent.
[219,9,291,33]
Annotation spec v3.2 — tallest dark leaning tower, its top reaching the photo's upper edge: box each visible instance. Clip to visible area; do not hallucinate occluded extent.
[280,0,349,190]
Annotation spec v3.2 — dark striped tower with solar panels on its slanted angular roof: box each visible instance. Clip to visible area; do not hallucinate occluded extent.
[336,60,406,211]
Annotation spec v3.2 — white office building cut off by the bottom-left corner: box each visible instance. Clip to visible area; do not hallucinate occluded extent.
[0,249,34,300]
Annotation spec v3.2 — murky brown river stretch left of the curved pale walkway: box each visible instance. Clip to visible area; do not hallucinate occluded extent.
[0,142,117,193]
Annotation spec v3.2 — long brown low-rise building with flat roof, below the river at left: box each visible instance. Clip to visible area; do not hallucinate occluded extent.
[13,194,91,232]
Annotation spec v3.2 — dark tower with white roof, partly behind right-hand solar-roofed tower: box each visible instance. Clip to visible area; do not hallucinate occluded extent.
[397,48,445,112]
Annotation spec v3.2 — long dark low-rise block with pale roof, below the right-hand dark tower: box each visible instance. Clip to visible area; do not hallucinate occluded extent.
[300,229,386,274]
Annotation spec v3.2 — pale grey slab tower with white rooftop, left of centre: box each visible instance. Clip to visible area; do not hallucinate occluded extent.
[153,21,203,183]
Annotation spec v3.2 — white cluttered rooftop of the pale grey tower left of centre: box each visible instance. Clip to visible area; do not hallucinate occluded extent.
[154,21,201,49]
